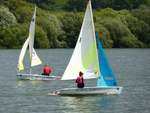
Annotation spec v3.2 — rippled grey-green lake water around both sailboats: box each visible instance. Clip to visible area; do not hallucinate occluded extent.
[0,49,150,113]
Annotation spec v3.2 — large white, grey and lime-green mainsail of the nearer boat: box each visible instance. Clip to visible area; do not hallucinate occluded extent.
[62,0,99,80]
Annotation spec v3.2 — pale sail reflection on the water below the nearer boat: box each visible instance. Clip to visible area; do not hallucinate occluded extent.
[61,96,111,113]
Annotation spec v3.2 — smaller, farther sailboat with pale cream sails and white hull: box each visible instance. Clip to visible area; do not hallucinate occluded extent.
[16,7,56,80]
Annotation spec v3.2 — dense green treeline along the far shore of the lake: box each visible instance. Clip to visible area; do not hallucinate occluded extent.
[0,0,150,48]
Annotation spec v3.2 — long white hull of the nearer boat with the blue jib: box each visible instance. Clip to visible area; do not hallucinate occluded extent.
[53,86,122,96]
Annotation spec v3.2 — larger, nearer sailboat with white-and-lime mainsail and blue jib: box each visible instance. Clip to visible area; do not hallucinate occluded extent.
[53,0,122,96]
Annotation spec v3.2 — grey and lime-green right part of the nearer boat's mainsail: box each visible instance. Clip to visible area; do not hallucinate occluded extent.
[80,0,99,75]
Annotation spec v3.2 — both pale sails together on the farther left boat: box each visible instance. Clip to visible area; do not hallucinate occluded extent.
[18,7,42,71]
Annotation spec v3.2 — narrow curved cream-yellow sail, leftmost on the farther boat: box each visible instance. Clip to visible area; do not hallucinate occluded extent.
[18,38,29,71]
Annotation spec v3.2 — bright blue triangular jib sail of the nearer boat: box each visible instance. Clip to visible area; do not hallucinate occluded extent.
[96,33,117,86]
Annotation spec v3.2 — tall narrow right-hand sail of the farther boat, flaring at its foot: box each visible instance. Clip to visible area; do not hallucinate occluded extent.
[29,7,42,67]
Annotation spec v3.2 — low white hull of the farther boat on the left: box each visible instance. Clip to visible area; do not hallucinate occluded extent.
[16,73,60,80]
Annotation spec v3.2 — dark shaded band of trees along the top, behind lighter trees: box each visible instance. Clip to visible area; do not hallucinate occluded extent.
[26,0,150,11]
